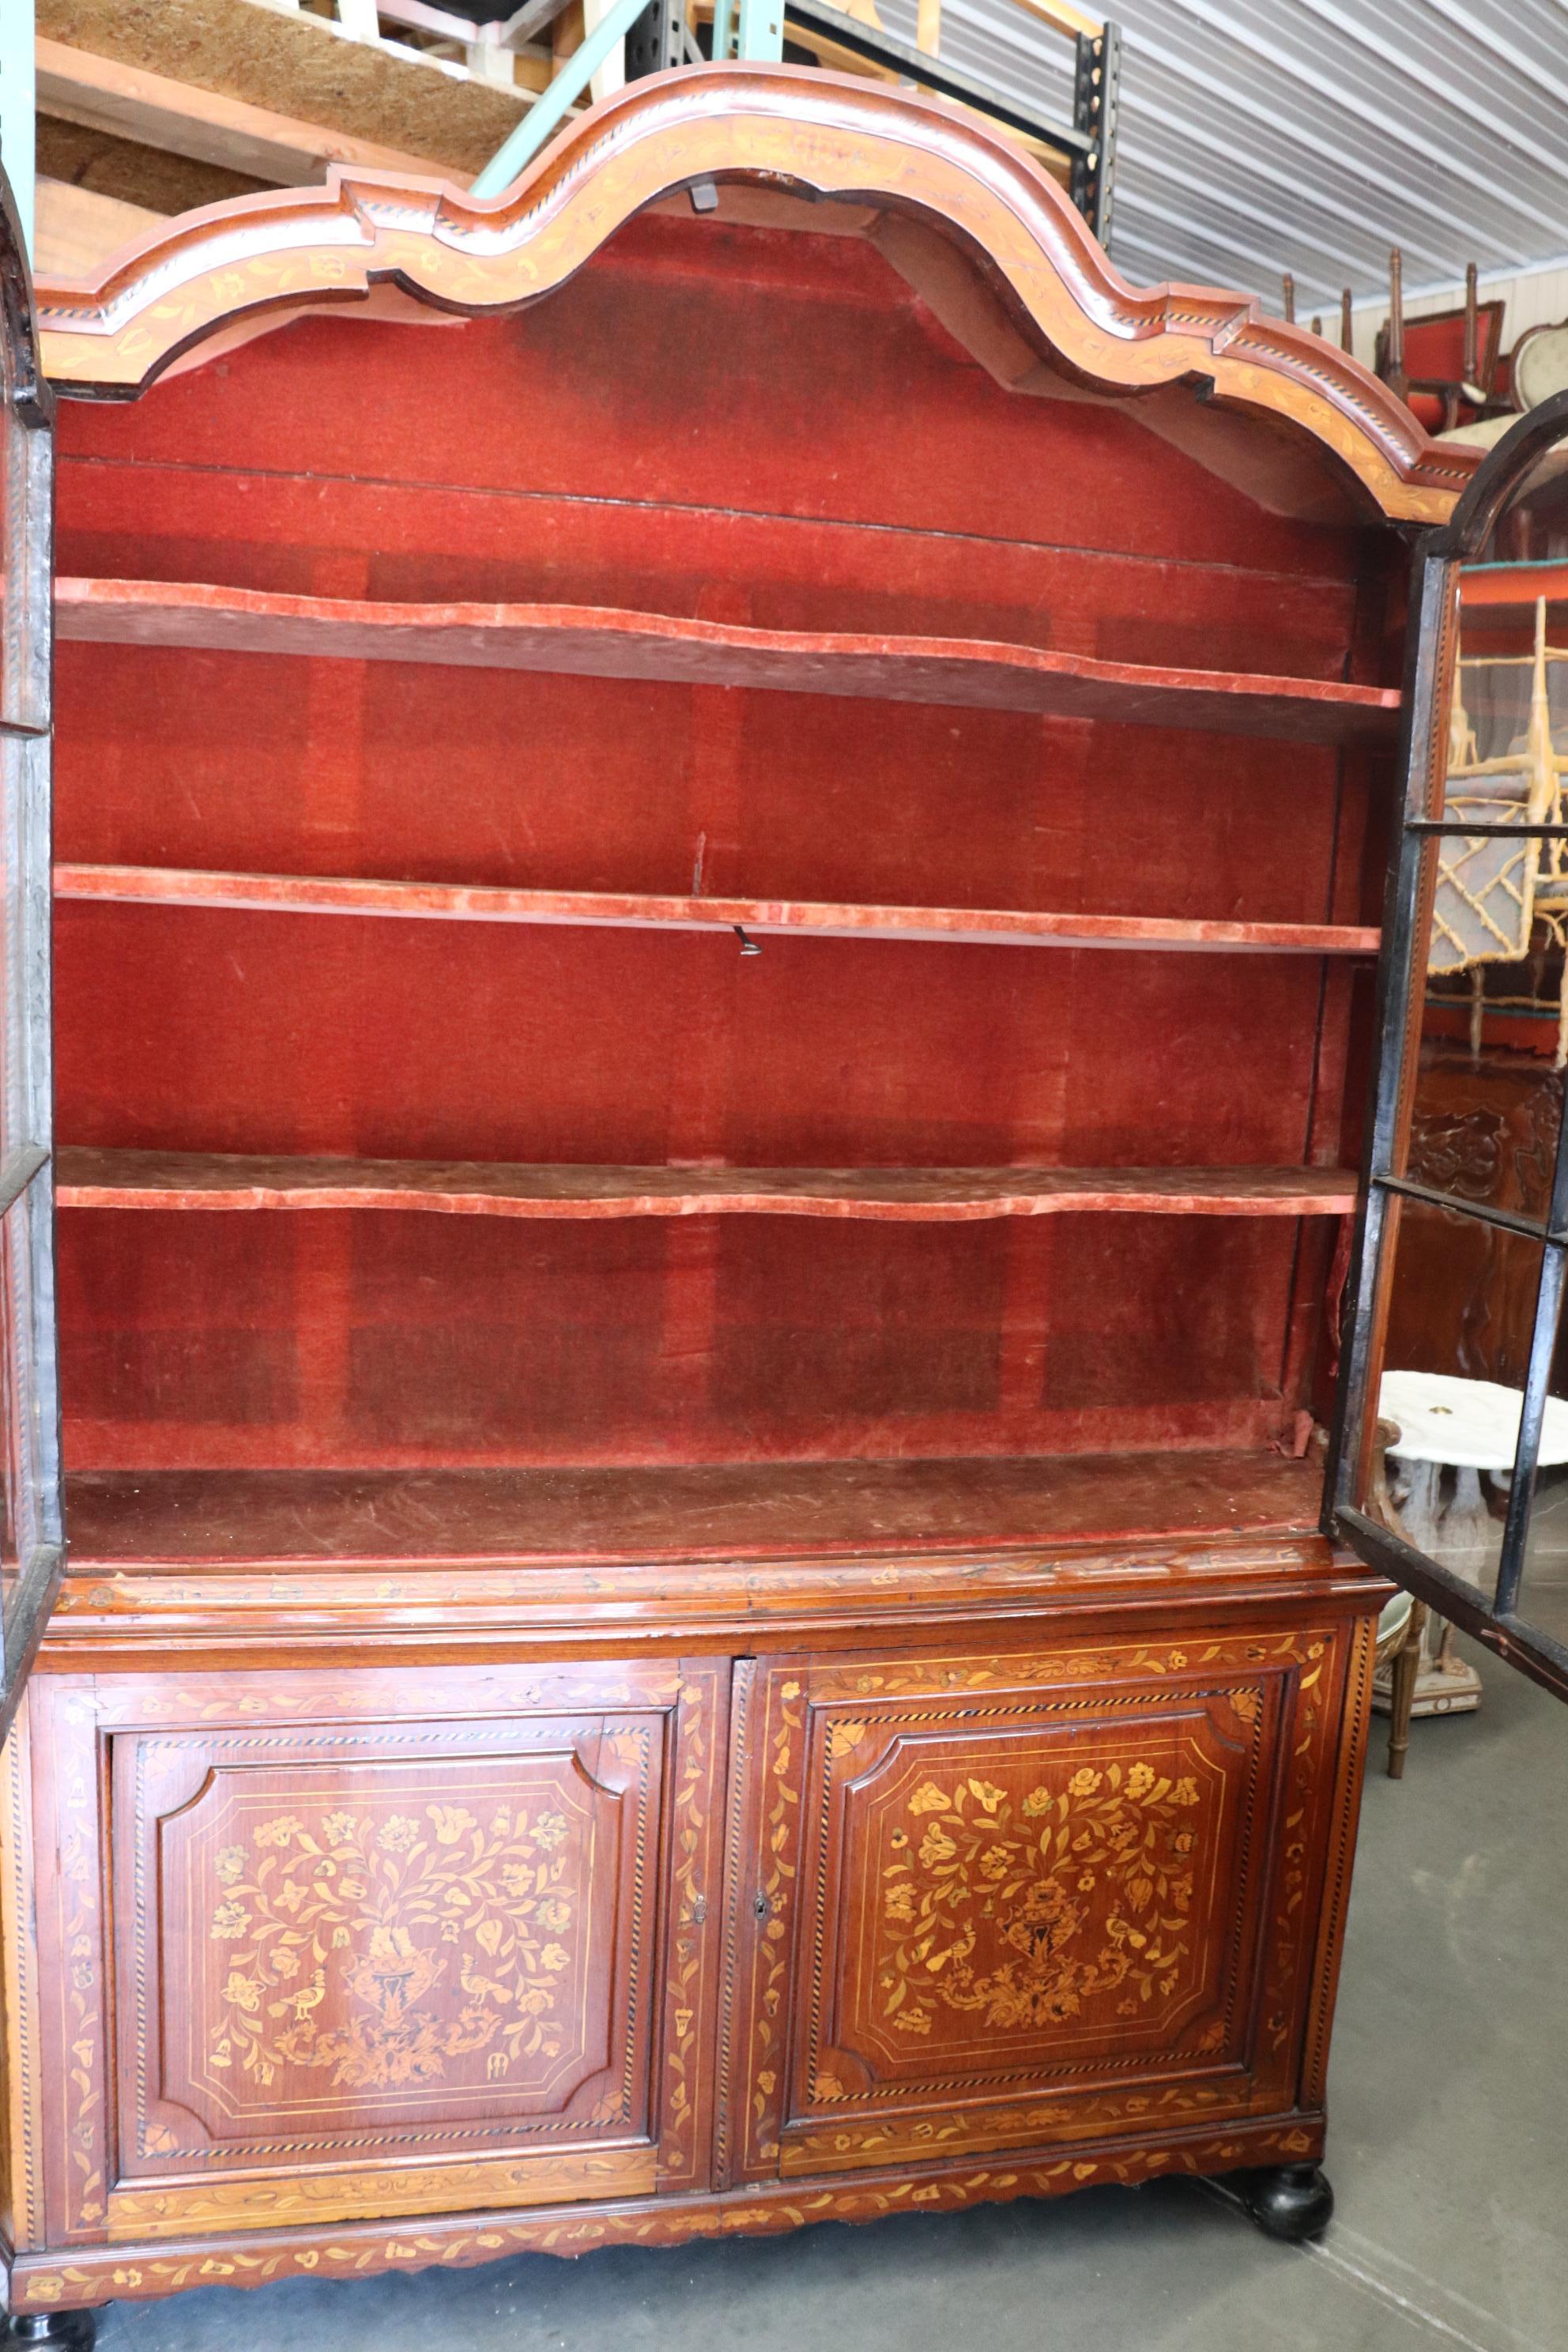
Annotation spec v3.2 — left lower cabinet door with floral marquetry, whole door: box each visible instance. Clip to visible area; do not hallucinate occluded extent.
[18,1660,729,2241]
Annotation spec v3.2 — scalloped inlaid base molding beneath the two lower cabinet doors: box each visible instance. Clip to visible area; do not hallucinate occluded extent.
[12,2114,1324,2312]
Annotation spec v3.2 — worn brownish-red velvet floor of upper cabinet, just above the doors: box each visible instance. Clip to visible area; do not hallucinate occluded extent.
[66,1451,1324,1576]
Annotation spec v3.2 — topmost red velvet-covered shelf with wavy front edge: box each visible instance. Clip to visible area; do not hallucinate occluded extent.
[54,579,1399,743]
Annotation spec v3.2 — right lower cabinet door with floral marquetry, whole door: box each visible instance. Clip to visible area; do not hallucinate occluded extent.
[719,1623,1363,2183]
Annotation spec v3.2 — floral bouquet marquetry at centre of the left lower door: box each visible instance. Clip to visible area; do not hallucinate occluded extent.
[207,1802,590,2091]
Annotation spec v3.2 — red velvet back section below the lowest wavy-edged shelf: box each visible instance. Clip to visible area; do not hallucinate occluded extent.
[61,1209,1295,1470]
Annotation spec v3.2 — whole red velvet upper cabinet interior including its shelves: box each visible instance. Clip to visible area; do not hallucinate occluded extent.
[56,212,1401,1562]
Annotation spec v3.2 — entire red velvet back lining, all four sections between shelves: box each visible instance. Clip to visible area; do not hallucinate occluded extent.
[56,221,1387,1468]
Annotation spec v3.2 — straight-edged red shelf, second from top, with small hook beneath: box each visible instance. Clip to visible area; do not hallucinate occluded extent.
[54,865,1380,955]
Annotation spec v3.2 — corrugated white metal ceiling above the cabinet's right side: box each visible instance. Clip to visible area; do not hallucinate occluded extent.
[879,0,1568,318]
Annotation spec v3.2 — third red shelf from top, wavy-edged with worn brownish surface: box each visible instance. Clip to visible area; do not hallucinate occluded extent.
[54,1145,1356,1225]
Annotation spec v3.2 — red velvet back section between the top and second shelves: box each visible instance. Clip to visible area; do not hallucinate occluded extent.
[56,644,1337,922]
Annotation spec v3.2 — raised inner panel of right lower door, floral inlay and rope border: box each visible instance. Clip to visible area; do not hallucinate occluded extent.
[785,1660,1276,2126]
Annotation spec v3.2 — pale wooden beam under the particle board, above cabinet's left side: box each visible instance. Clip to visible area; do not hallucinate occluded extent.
[38,40,461,188]
